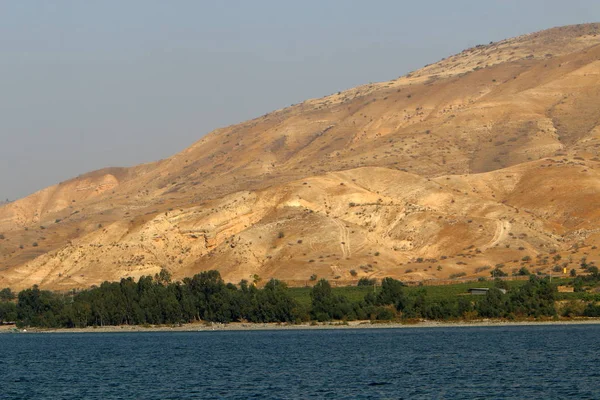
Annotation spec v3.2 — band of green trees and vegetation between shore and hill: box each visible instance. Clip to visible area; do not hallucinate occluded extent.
[0,268,600,328]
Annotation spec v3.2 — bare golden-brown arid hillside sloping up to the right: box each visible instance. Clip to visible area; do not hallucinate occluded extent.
[0,24,600,289]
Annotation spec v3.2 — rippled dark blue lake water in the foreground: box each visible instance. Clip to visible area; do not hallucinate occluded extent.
[0,325,600,399]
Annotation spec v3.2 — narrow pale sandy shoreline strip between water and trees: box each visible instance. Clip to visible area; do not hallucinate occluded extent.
[0,318,600,334]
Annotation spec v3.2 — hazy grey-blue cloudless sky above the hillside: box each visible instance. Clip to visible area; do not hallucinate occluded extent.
[0,0,600,200]
